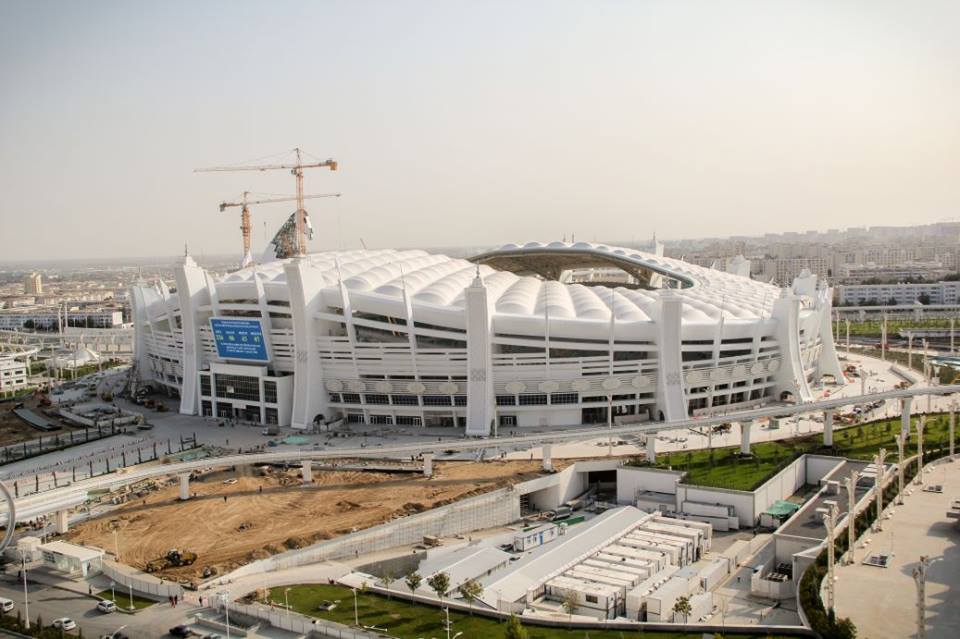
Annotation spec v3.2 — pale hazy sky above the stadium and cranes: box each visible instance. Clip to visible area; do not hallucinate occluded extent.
[0,0,960,260]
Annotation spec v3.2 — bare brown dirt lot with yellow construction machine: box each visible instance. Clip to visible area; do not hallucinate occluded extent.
[69,461,561,579]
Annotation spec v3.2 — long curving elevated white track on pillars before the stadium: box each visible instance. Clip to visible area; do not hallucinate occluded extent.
[7,384,960,521]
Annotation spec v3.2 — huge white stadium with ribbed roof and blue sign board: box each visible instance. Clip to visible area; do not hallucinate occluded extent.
[131,242,841,436]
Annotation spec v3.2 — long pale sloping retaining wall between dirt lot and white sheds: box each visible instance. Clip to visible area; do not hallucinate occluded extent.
[222,488,520,580]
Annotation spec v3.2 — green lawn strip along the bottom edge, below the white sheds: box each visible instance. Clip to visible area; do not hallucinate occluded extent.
[270,584,788,639]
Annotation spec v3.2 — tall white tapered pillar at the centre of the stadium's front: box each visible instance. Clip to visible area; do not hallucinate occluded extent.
[464,267,496,437]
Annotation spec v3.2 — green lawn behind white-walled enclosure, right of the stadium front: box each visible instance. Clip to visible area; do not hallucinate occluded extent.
[631,415,948,490]
